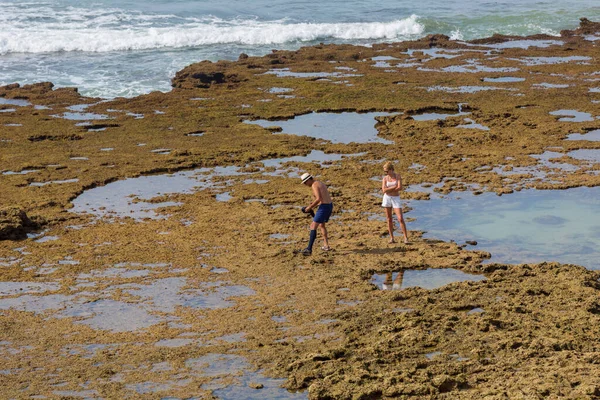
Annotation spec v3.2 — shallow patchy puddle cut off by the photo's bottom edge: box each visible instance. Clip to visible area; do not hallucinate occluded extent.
[185,353,308,400]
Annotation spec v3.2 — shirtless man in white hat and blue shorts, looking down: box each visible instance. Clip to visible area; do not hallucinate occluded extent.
[300,173,333,256]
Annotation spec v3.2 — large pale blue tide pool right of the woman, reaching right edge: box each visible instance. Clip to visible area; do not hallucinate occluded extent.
[408,187,600,269]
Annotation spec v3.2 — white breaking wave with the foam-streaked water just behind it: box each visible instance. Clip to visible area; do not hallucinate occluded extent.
[0,3,424,54]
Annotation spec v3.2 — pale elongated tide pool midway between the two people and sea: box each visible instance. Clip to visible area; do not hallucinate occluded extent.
[245,112,394,144]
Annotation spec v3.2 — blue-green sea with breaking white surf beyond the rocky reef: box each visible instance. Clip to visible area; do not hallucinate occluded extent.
[0,0,600,98]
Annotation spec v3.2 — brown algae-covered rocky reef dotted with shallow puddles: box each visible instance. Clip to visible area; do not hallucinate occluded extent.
[0,19,600,399]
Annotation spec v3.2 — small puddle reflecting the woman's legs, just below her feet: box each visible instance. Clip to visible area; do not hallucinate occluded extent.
[371,268,486,290]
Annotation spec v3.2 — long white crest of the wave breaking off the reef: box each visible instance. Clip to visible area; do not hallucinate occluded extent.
[0,15,424,54]
